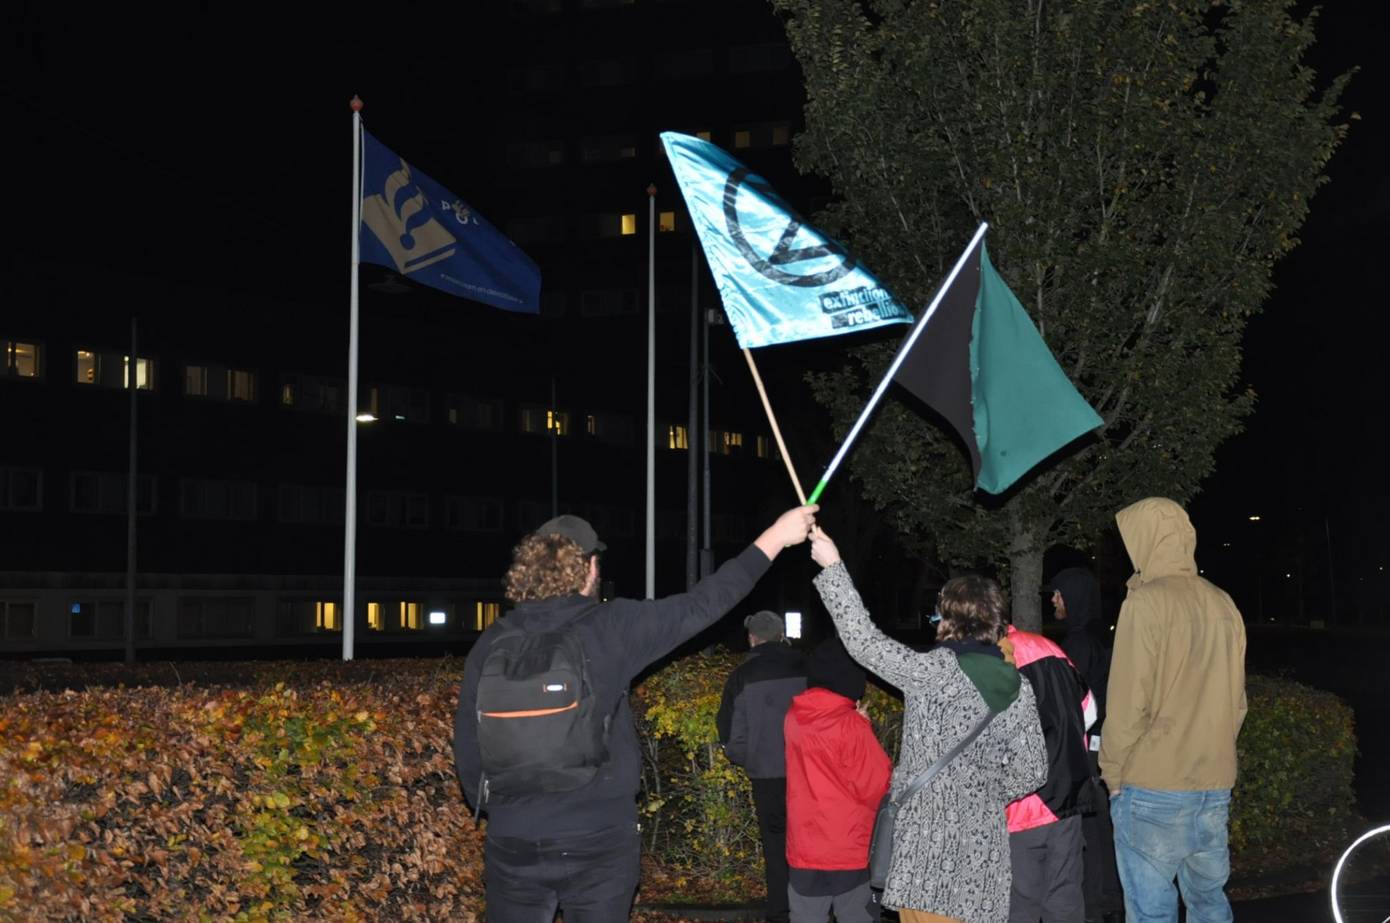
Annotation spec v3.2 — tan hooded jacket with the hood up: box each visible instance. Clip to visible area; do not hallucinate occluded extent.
[1101,498,1245,794]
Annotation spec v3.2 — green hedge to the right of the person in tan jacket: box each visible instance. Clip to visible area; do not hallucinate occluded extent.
[1230,676,1357,865]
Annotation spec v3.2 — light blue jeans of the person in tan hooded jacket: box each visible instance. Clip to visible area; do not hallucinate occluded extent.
[1111,785,1233,923]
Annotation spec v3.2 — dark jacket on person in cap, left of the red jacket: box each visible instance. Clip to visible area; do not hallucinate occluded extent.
[714,641,806,778]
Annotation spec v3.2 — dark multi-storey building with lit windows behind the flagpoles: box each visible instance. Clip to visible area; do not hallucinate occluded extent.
[0,0,828,656]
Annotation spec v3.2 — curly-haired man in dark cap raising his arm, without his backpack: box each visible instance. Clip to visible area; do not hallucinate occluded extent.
[453,506,817,923]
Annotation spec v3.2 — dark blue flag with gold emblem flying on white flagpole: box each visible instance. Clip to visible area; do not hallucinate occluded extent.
[361,132,541,314]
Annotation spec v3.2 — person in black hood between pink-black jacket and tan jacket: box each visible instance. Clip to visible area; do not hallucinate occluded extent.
[1051,567,1125,922]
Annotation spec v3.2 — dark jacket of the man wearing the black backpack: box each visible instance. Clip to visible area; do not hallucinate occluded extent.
[453,545,770,837]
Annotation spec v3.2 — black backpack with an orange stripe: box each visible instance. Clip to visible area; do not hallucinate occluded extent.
[477,606,612,808]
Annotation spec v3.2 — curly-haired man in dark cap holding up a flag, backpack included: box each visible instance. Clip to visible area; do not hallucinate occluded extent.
[453,506,817,923]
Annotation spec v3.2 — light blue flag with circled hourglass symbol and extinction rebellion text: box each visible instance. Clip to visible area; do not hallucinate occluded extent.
[662,132,912,349]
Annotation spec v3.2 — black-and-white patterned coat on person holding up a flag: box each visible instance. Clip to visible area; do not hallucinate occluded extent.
[816,564,1047,923]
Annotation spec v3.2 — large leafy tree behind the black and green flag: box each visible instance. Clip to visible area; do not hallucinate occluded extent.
[773,0,1350,628]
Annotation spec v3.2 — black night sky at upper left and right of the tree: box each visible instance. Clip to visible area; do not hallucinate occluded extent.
[8,0,1390,622]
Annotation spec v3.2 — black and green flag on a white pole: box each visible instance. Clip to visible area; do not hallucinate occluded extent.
[894,235,1104,493]
